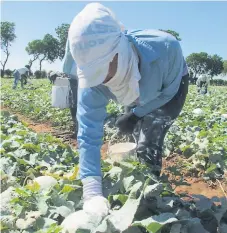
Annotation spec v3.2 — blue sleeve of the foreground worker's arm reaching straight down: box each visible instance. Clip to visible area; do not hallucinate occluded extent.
[77,87,109,179]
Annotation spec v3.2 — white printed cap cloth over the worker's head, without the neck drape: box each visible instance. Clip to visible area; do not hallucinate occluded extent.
[69,3,121,87]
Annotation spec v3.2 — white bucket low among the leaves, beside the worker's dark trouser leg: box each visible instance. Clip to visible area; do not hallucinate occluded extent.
[107,142,136,162]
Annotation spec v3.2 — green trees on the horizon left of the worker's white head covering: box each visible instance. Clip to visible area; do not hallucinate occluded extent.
[1,22,70,77]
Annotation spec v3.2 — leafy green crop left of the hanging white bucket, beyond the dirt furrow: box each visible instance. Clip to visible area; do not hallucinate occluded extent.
[1,79,72,131]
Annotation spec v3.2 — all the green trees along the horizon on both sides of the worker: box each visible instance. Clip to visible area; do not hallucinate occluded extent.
[1,21,227,80]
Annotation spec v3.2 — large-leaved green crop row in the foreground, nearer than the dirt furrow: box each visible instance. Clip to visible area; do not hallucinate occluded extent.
[0,111,226,233]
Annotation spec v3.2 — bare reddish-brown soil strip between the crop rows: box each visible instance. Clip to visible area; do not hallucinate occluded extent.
[1,106,227,198]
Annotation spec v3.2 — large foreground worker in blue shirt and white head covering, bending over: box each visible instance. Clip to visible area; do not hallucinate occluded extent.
[63,3,189,223]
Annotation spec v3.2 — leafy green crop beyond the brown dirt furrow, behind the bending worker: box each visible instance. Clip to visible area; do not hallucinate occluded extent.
[1,79,227,178]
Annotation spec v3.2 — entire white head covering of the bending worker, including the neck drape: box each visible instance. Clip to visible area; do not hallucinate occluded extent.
[68,3,141,105]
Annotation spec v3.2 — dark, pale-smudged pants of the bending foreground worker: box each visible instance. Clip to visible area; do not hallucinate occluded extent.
[126,75,189,176]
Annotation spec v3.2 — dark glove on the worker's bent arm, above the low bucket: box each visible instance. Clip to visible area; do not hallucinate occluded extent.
[116,112,141,134]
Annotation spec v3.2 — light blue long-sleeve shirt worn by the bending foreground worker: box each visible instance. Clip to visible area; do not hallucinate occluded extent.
[63,30,187,178]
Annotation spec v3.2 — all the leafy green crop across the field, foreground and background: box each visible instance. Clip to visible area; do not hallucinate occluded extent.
[0,79,227,233]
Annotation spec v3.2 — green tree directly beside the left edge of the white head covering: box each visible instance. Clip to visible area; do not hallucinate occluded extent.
[55,23,70,60]
